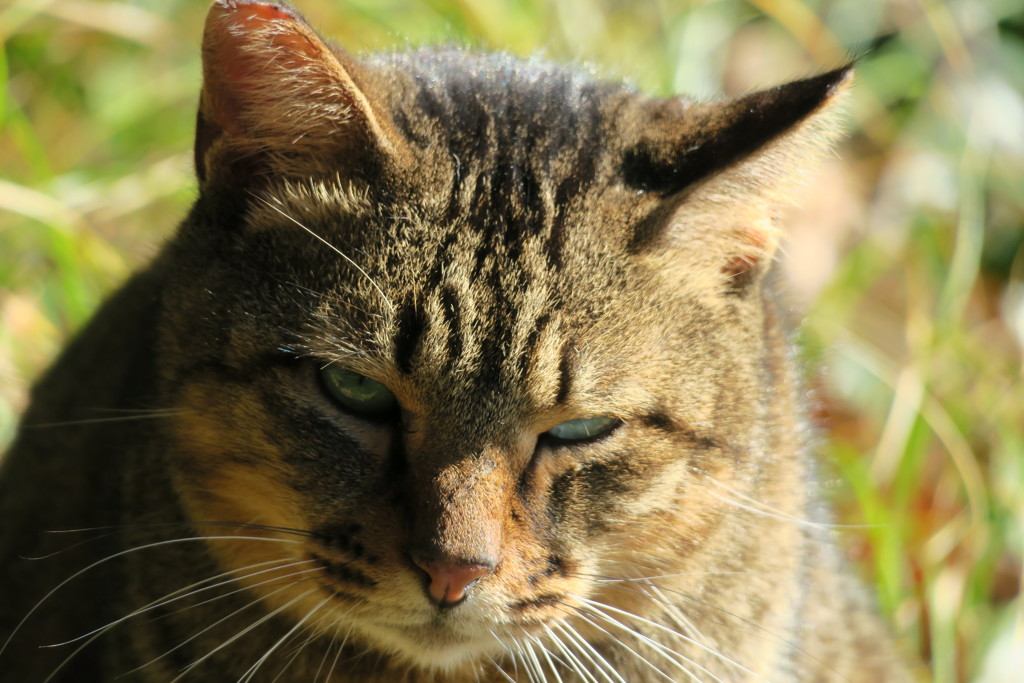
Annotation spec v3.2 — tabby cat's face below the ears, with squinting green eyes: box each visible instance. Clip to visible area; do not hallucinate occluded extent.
[157,143,757,663]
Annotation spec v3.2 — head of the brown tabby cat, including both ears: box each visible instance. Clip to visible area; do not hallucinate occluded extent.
[153,1,849,668]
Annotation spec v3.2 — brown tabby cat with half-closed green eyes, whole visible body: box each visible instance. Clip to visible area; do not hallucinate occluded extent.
[0,0,910,683]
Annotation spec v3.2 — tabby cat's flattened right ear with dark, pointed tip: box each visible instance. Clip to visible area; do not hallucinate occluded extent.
[623,65,853,293]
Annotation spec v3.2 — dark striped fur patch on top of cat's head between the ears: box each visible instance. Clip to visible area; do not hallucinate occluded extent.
[387,50,623,275]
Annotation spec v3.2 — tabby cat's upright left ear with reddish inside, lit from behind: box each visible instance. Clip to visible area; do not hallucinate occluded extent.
[196,0,401,188]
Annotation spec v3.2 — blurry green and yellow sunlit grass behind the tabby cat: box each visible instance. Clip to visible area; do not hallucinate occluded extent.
[0,0,1024,681]
